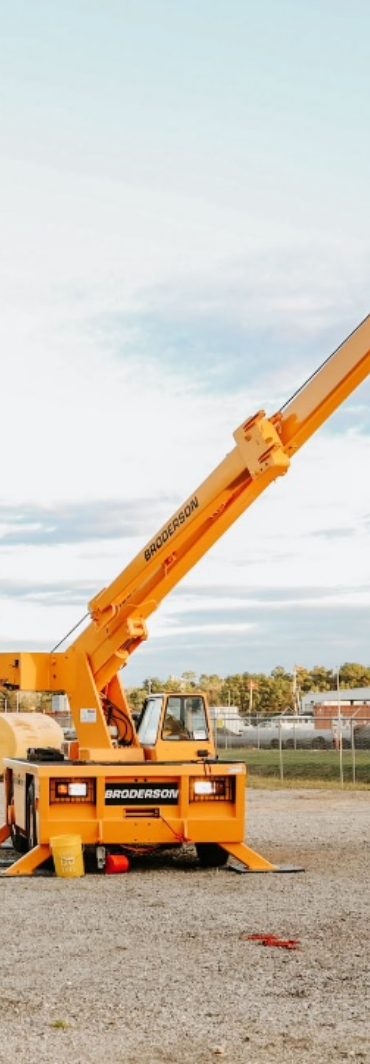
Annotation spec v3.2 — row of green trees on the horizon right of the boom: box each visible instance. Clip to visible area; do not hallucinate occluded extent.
[127,662,370,715]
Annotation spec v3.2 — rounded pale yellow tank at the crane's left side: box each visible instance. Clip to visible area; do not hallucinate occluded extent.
[0,713,64,776]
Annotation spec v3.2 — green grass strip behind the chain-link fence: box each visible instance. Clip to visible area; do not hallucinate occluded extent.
[220,748,370,791]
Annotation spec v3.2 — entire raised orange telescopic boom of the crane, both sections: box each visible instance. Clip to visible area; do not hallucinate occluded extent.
[68,316,370,687]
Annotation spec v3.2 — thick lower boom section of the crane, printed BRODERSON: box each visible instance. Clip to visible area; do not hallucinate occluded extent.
[69,411,289,689]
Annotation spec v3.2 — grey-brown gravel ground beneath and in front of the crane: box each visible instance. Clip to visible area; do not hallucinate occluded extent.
[0,789,370,1064]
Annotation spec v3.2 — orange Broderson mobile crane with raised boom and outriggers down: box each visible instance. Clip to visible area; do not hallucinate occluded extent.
[0,317,370,876]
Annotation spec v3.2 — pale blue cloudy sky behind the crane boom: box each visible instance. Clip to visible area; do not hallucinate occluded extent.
[0,0,370,686]
